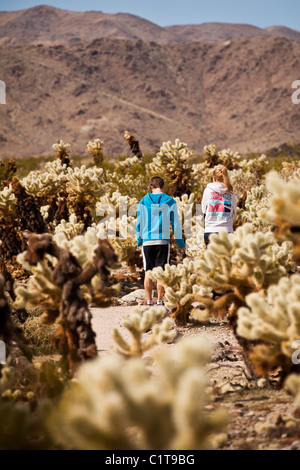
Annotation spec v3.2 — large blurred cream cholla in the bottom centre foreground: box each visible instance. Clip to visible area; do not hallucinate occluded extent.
[48,337,226,450]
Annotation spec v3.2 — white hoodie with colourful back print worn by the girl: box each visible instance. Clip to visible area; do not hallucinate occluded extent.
[201,183,237,233]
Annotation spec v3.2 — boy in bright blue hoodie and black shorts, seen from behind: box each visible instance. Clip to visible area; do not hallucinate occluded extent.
[136,176,185,305]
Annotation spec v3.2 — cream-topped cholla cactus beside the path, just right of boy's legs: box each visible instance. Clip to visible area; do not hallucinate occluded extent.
[148,258,210,325]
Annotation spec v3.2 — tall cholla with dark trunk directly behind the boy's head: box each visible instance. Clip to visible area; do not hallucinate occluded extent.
[149,139,194,196]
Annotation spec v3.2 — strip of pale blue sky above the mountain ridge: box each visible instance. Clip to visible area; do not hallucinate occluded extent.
[0,0,300,30]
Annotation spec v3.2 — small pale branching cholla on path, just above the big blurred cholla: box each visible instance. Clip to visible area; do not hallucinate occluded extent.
[113,307,177,357]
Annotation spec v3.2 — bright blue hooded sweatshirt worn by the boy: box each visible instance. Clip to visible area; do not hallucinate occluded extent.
[136,193,185,248]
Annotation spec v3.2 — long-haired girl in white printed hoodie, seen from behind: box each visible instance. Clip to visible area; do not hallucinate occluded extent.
[202,165,237,245]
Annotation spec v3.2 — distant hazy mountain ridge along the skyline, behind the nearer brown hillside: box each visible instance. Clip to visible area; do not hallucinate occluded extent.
[0,5,300,45]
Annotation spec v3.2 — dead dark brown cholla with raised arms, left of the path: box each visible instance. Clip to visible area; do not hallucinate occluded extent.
[20,234,116,371]
